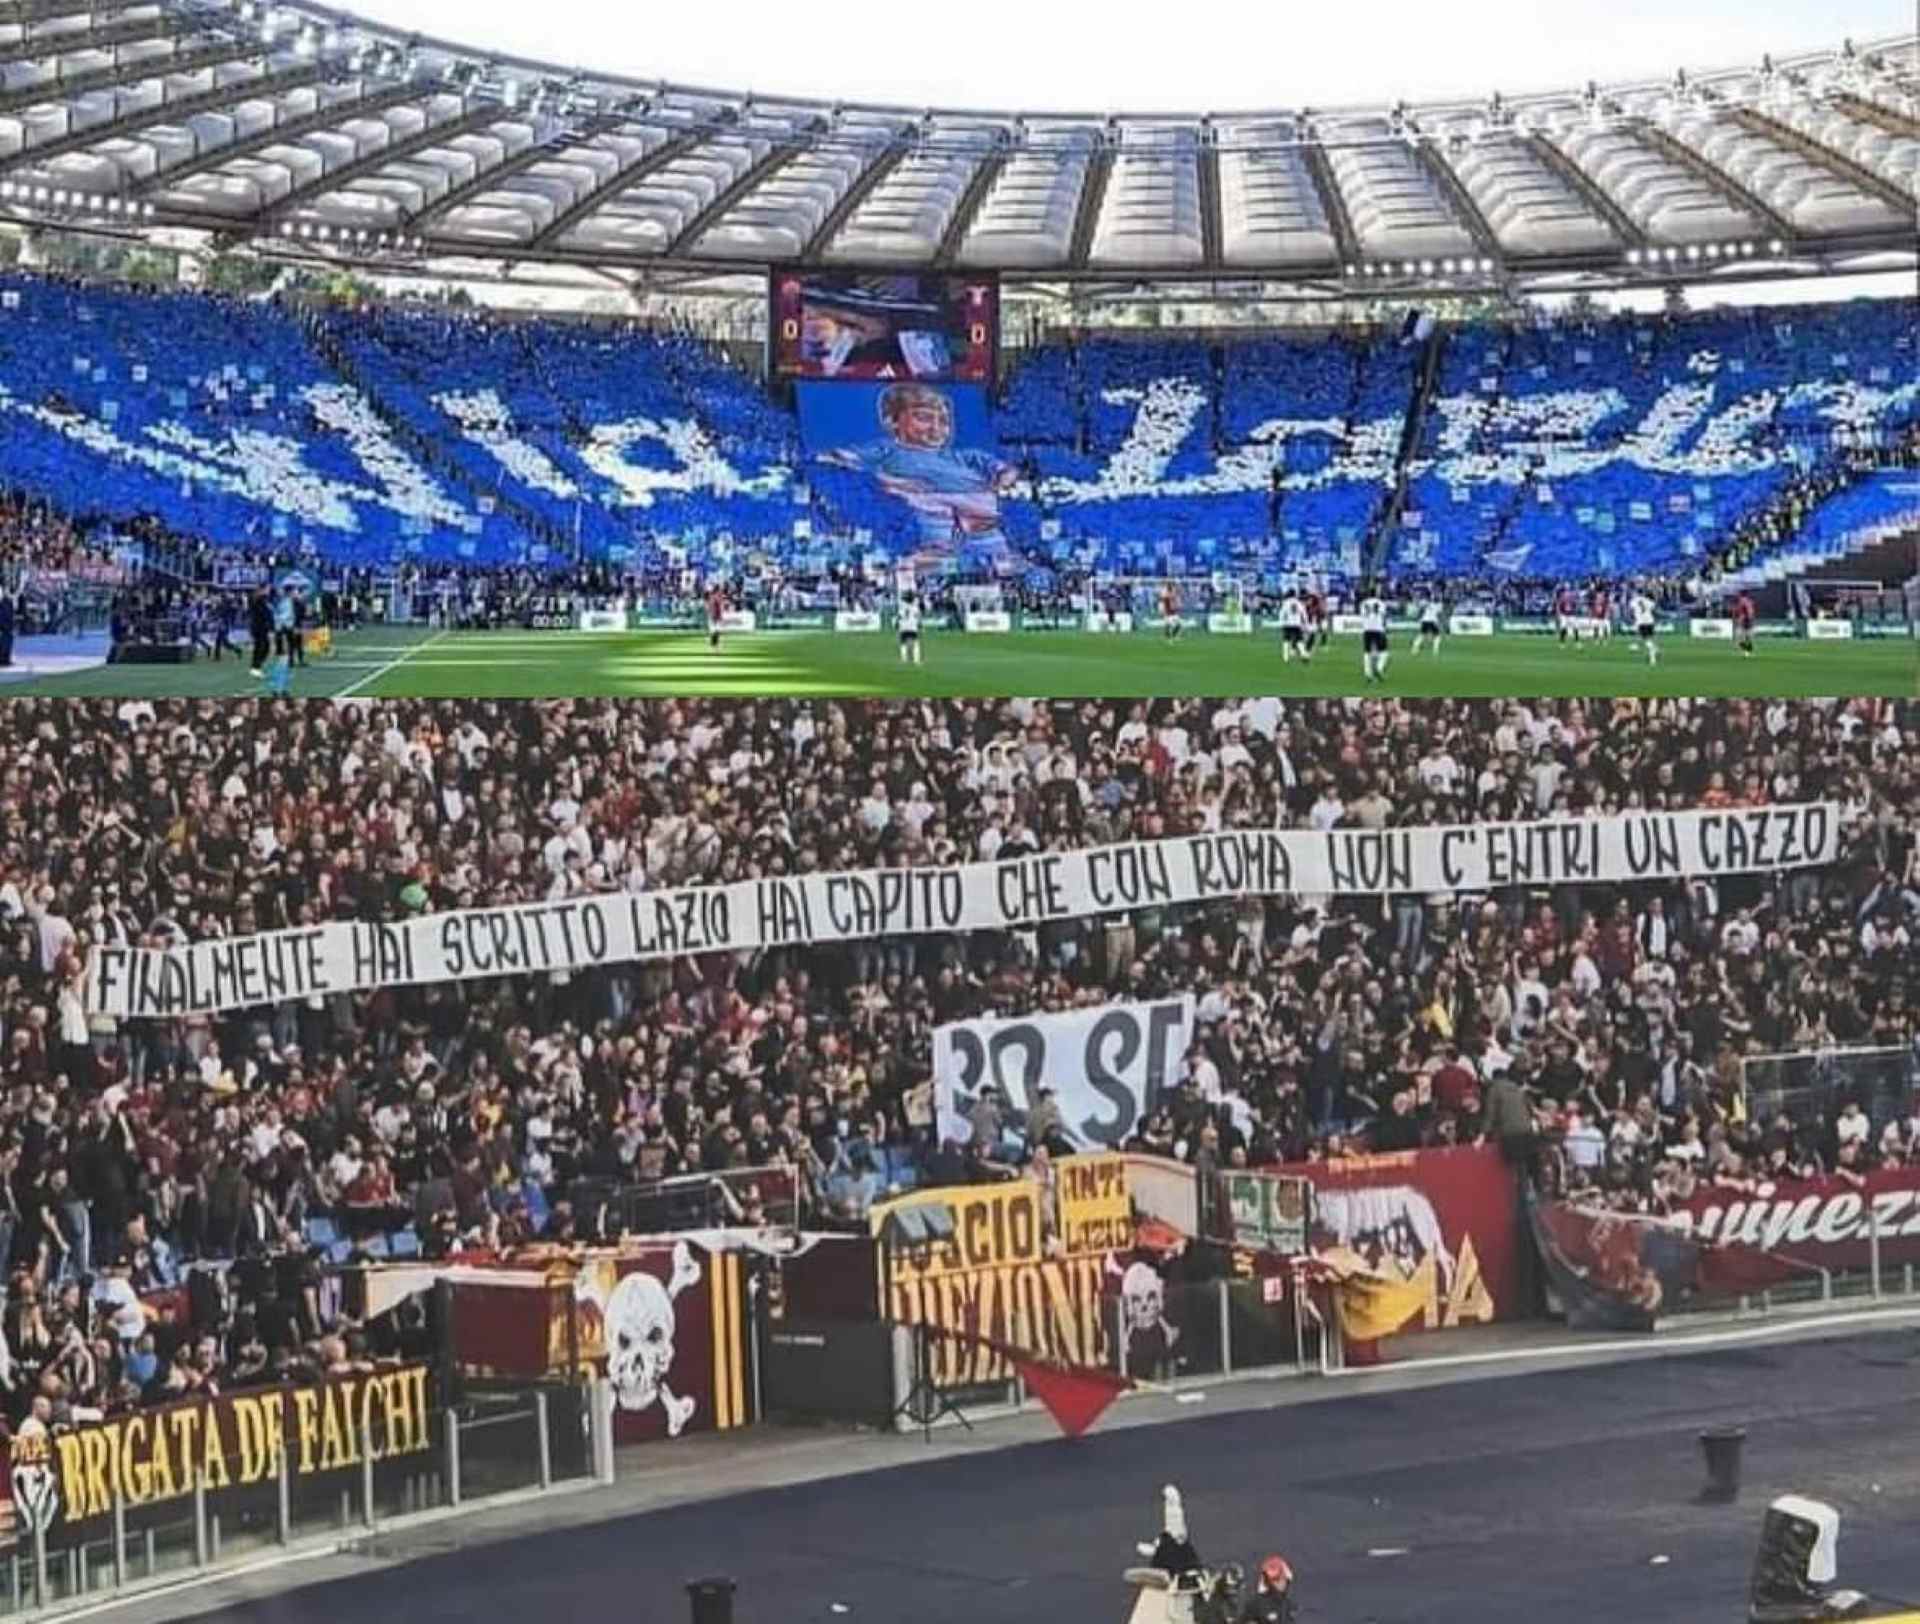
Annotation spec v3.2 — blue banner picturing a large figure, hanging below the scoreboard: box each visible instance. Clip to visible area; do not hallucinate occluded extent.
[799,382,1014,564]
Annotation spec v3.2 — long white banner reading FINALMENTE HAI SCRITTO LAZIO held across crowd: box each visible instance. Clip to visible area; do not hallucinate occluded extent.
[84,802,1841,1017]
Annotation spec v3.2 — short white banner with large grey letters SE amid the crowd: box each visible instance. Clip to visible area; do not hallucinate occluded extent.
[933,996,1194,1150]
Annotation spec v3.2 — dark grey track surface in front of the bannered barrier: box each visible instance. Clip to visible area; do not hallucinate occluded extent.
[210,1336,1920,1624]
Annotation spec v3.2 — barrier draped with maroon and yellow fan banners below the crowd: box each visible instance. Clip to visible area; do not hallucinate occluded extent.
[0,1148,1920,1614]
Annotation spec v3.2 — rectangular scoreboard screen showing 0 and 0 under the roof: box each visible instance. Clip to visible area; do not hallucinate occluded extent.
[766,271,1000,384]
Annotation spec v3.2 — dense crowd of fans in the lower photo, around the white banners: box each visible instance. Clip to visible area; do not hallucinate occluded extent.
[0,697,1920,1424]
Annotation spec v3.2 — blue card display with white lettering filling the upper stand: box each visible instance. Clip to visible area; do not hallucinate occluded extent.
[0,276,1920,580]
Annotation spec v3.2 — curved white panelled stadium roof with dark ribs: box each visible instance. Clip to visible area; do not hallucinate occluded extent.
[0,0,1920,294]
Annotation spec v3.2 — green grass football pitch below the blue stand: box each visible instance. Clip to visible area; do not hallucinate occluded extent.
[0,628,1920,699]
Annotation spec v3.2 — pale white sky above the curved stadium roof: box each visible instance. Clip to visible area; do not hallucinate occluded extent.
[348,0,1914,113]
